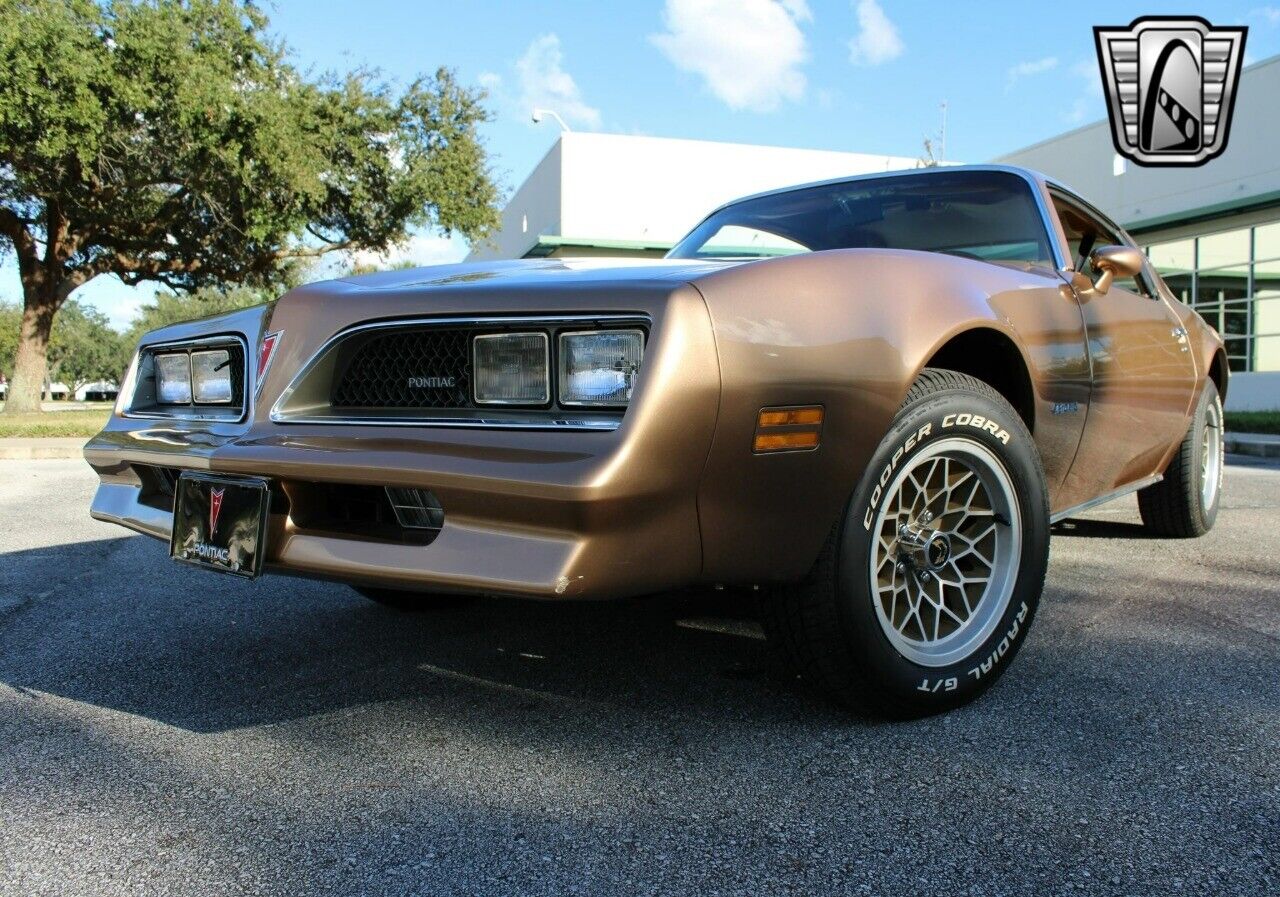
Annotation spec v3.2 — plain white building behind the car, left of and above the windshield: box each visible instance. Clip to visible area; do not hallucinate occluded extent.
[467,132,916,261]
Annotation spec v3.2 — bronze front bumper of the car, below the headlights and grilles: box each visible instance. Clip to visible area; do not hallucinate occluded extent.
[84,294,719,598]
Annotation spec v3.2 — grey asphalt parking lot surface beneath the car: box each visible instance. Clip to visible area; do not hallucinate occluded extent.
[0,461,1280,896]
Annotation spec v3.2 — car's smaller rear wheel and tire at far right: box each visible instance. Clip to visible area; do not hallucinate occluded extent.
[1138,380,1225,539]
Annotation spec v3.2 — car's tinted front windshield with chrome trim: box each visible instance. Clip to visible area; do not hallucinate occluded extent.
[667,170,1051,265]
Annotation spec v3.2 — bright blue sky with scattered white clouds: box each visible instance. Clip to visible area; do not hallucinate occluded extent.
[0,0,1280,326]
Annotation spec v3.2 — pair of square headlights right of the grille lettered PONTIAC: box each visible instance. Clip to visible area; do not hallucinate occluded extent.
[472,330,644,407]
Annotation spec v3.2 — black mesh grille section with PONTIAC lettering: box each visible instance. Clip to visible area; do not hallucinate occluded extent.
[332,329,474,408]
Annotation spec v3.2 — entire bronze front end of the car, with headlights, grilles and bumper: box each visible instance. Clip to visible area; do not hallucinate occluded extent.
[84,262,719,598]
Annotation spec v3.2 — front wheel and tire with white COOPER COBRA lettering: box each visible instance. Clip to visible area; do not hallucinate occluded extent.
[764,369,1050,718]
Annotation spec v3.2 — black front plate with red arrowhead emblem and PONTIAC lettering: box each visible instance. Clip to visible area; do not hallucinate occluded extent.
[169,472,270,578]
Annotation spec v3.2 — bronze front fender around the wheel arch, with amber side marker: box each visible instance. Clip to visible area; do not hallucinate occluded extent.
[694,250,1087,582]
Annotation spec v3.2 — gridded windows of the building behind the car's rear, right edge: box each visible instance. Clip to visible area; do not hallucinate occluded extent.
[1147,221,1280,371]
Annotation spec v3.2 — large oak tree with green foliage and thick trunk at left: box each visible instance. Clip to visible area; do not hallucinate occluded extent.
[0,0,498,411]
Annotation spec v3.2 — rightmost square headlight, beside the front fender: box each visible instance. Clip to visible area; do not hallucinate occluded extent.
[559,330,644,406]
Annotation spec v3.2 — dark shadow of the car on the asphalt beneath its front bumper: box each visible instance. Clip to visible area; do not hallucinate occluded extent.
[0,537,838,732]
